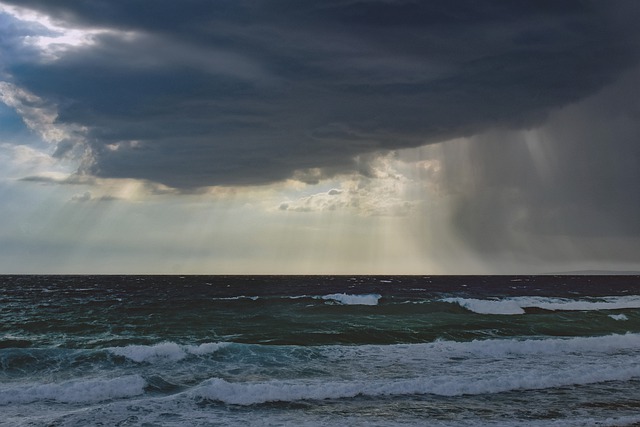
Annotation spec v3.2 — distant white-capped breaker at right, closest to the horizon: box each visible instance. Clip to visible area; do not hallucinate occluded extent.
[440,295,640,315]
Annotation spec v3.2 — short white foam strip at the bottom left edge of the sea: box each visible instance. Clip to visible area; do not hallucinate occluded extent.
[0,375,146,405]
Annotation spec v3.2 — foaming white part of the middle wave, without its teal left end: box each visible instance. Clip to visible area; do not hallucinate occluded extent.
[112,333,640,366]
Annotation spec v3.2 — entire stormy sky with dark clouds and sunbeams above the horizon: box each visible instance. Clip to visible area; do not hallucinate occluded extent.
[0,0,640,274]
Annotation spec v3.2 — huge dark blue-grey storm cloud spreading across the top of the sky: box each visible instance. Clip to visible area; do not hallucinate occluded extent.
[3,0,640,189]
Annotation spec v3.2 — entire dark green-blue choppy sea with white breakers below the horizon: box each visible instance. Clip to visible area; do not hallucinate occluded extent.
[0,276,640,426]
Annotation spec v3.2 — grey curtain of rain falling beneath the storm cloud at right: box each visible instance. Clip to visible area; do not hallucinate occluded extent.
[412,68,640,262]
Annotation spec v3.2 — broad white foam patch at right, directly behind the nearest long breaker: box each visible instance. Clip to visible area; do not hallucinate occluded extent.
[318,334,640,376]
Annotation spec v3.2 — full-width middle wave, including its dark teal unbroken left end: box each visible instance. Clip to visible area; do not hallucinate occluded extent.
[11,332,640,373]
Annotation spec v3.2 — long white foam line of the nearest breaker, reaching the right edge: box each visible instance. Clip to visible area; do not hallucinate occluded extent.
[194,365,640,405]
